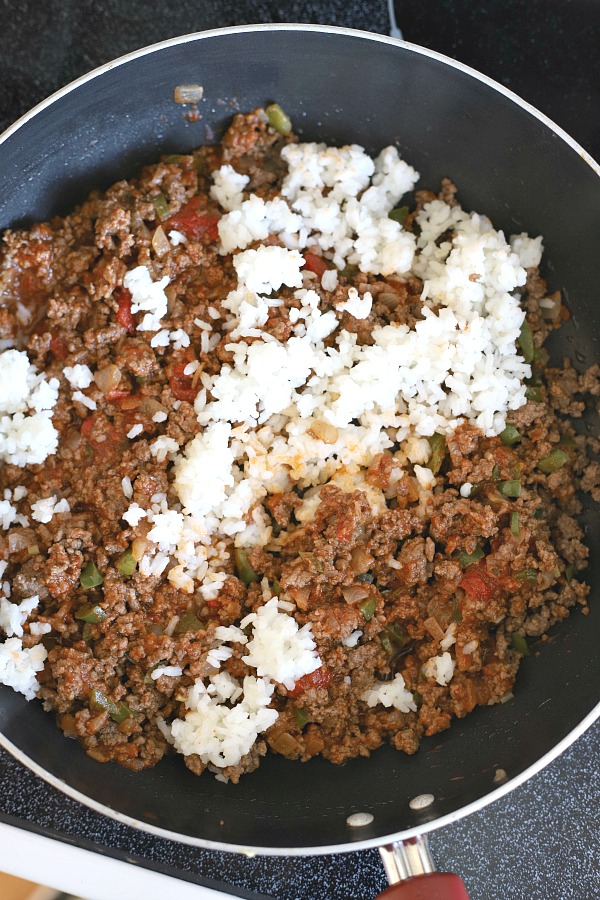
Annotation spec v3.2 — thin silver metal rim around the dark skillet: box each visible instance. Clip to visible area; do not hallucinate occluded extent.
[0,23,600,856]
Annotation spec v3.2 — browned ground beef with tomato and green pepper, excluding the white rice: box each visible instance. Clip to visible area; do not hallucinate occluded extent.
[0,112,599,781]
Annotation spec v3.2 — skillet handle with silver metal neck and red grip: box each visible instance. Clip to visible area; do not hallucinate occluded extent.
[377,835,469,900]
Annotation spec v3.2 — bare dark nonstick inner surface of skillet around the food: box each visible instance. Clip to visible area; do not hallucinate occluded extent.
[0,26,600,852]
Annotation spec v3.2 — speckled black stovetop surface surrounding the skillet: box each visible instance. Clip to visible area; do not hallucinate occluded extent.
[0,0,600,900]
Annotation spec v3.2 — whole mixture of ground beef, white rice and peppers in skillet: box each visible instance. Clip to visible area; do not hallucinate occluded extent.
[0,107,599,782]
